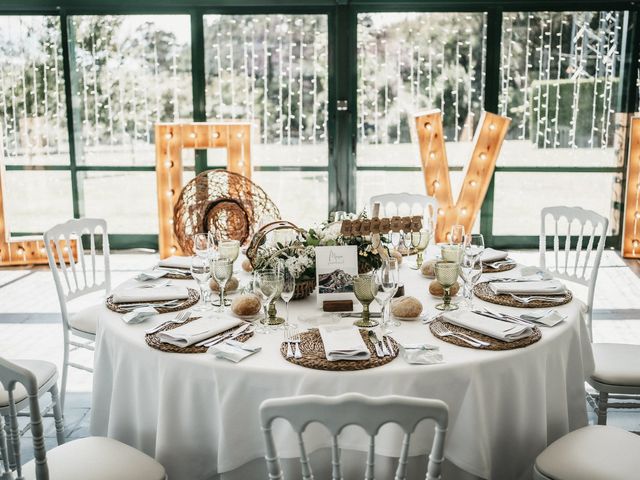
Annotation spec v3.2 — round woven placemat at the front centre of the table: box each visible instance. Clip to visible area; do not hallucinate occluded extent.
[280,328,400,372]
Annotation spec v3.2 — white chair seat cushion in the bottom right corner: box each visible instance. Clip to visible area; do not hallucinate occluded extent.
[536,425,640,480]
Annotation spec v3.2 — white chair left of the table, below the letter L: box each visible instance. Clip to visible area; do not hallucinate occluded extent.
[44,218,111,412]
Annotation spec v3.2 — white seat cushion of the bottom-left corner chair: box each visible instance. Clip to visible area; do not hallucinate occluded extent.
[23,437,165,480]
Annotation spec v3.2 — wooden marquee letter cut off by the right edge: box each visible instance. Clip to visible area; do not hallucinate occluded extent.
[622,116,640,258]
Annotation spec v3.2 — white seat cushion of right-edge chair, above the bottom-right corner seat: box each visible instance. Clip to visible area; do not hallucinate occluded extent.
[591,343,640,387]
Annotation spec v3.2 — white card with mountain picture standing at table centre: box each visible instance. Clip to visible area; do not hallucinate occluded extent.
[316,245,358,305]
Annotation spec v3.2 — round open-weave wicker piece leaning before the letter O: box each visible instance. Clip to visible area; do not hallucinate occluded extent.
[173,170,280,255]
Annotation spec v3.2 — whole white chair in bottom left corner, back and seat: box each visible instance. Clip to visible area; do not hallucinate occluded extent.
[0,357,166,480]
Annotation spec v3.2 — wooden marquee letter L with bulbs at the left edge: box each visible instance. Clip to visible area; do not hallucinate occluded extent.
[0,132,78,267]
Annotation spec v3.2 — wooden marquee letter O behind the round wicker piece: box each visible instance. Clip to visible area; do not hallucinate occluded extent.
[155,122,252,258]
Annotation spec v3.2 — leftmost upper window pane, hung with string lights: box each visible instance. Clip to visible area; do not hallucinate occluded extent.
[0,16,69,165]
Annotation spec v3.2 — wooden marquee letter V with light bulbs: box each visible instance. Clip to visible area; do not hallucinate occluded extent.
[416,110,511,242]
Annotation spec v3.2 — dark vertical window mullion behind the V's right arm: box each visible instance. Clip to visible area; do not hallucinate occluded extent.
[480,8,502,245]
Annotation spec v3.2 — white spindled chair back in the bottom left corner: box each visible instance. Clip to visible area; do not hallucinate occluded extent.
[0,357,49,480]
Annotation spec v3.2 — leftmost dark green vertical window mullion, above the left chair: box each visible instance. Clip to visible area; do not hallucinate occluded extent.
[60,13,84,218]
